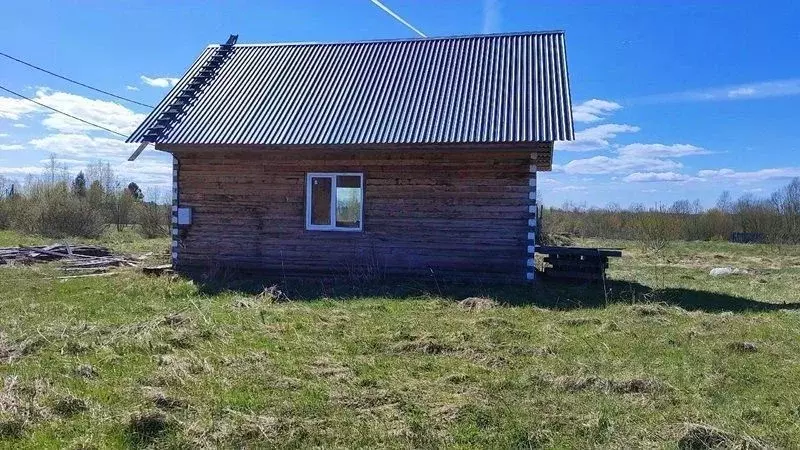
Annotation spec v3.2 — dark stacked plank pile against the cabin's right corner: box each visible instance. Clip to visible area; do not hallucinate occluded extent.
[536,246,622,281]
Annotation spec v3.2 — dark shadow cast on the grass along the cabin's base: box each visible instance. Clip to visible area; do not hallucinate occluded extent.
[189,273,800,313]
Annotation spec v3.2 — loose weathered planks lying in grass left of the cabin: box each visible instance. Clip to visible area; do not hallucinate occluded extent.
[0,244,144,276]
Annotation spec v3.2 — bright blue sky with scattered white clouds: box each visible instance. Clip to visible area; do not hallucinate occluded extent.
[0,0,800,206]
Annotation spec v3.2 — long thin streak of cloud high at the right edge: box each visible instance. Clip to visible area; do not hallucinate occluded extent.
[630,78,800,104]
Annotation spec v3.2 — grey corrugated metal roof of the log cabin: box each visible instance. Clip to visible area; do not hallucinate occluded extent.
[128,32,573,145]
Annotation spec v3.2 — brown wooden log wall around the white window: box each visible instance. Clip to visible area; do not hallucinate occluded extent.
[172,143,552,282]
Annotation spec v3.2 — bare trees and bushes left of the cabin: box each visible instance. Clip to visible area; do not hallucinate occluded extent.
[0,157,171,238]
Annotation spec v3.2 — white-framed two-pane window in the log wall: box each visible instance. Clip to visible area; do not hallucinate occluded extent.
[306,173,364,231]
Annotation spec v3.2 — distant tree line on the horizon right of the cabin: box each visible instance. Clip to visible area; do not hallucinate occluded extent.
[541,178,800,247]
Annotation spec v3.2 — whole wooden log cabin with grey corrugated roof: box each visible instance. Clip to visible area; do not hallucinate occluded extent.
[128,32,573,283]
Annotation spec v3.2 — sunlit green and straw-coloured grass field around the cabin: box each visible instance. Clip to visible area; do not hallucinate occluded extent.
[0,233,800,448]
